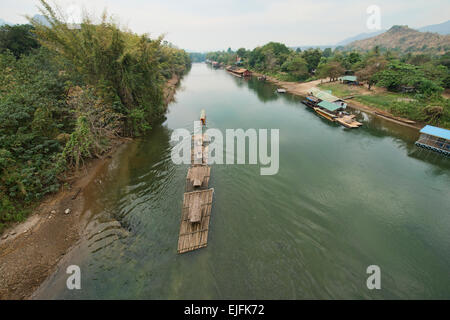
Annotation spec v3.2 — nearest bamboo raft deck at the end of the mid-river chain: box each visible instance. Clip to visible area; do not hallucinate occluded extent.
[178,188,214,253]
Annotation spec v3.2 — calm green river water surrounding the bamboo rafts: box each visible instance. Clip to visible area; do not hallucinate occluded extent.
[34,64,450,299]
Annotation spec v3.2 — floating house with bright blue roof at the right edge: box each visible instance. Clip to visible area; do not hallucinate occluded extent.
[416,125,450,156]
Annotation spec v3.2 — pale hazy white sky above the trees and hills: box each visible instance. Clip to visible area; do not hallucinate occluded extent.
[0,0,450,51]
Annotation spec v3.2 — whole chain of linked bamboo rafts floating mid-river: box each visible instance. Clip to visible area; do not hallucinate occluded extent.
[177,110,214,253]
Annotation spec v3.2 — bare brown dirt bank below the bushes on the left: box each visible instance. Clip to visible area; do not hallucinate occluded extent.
[0,76,180,300]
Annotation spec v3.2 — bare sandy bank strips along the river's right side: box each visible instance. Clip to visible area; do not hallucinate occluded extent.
[253,72,424,130]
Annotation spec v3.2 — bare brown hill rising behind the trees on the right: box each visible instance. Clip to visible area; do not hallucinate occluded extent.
[344,26,450,54]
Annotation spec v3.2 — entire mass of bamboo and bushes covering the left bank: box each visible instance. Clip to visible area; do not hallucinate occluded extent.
[0,1,191,232]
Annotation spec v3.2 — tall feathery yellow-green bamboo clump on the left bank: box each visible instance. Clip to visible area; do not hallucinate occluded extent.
[31,0,190,136]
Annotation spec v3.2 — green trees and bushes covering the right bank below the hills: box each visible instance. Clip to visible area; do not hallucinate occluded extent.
[205,42,450,128]
